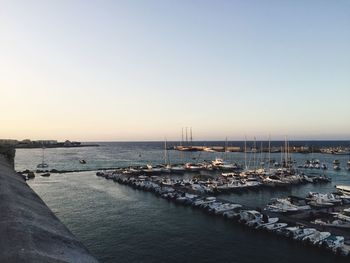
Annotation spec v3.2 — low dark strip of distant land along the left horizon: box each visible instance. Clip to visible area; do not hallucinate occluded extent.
[0,139,99,148]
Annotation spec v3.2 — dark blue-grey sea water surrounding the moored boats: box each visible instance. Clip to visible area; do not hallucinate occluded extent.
[15,141,350,263]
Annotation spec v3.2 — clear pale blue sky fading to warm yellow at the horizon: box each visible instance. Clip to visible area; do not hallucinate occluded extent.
[0,0,350,141]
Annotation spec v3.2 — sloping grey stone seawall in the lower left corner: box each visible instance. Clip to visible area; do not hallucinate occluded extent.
[0,147,98,262]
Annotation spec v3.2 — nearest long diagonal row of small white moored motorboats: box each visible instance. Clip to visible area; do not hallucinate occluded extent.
[96,172,349,256]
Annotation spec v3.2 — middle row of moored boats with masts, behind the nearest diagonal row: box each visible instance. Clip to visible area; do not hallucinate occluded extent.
[98,160,331,194]
